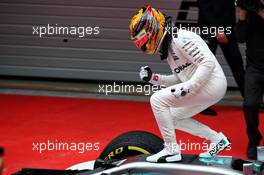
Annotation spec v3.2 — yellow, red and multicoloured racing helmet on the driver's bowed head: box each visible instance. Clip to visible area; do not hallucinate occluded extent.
[129,5,166,54]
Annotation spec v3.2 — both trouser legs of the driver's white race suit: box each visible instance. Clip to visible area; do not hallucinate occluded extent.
[150,78,226,151]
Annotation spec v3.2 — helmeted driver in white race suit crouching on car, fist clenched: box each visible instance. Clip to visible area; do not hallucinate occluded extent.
[129,5,230,162]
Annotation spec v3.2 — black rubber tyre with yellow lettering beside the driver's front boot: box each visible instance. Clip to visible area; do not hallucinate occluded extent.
[95,131,163,168]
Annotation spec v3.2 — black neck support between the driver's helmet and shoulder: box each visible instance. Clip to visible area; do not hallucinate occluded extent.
[158,16,174,60]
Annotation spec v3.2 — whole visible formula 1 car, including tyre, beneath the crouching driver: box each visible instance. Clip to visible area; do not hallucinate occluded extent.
[14,131,264,175]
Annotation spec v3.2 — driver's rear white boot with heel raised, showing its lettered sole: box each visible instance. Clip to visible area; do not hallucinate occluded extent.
[199,132,230,158]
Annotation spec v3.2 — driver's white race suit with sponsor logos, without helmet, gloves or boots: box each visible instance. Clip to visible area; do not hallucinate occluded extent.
[150,30,227,145]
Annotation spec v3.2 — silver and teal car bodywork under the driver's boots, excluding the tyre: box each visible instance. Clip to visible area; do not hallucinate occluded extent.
[12,154,264,175]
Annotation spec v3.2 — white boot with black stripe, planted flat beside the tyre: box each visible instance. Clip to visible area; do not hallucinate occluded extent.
[146,144,182,163]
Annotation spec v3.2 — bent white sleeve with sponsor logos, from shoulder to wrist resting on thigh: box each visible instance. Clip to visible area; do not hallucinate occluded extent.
[177,37,216,91]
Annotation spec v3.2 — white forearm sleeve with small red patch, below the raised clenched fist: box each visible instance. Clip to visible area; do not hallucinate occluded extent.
[149,73,181,87]
